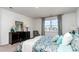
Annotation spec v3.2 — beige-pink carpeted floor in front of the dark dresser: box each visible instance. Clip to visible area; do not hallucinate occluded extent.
[0,43,18,52]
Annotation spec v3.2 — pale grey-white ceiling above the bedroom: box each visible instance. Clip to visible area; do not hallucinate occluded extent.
[5,7,77,18]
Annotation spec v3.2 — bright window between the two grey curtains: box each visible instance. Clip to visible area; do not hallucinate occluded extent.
[45,17,58,32]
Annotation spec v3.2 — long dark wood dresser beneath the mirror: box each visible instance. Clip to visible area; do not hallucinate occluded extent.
[9,31,30,44]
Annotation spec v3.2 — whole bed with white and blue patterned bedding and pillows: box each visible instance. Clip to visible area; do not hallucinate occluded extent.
[18,33,79,52]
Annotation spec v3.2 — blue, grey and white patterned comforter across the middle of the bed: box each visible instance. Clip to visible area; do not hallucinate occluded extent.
[32,36,62,52]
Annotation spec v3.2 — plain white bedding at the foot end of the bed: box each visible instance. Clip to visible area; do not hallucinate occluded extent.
[22,36,42,52]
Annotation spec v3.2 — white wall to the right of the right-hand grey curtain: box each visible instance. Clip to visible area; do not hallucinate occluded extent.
[62,12,77,34]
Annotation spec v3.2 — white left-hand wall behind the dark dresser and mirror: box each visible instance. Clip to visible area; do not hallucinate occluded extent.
[1,9,33,45]
